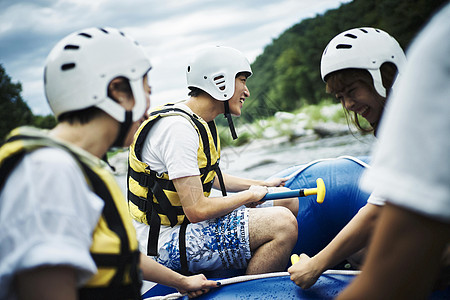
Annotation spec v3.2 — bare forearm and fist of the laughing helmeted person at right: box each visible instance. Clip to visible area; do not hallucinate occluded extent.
[288,203,383,289]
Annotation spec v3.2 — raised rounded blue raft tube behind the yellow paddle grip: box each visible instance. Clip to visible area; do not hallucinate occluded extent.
[278,156,370,256]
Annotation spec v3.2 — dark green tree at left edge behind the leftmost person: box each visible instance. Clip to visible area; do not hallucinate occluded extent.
[0,64,33,141]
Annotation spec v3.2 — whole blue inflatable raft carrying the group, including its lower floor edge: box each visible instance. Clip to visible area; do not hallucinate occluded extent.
[143,157,450,299]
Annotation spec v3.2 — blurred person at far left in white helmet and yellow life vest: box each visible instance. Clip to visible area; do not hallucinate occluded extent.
[0,28,215,299]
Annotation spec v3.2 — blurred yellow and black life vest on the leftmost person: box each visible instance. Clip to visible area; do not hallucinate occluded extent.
[0,127,142,299]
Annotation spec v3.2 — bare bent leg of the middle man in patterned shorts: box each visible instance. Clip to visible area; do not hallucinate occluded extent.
[246,207,298,274]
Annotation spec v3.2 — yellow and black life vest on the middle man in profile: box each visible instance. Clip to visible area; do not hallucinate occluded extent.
[128,104,226,262]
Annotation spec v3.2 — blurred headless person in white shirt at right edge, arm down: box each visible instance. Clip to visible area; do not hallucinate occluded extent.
[338,4,450,299]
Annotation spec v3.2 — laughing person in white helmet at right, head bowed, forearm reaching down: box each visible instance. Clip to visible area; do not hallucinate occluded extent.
[288,27,406,289]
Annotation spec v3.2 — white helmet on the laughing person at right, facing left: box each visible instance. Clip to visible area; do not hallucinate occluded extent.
[320,27,406,97]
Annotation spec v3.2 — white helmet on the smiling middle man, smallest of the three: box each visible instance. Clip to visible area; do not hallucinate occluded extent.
[186,46,252,101]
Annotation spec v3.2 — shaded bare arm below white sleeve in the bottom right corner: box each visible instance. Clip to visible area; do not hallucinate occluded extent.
[338,203,450,299]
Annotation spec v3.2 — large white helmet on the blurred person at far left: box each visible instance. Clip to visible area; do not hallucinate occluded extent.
[44,28,151,123]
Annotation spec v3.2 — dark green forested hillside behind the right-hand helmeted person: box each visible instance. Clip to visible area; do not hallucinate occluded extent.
[232,0,447,125]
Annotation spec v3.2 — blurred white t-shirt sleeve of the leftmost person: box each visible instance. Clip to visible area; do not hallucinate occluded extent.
[0,148,103,298]
